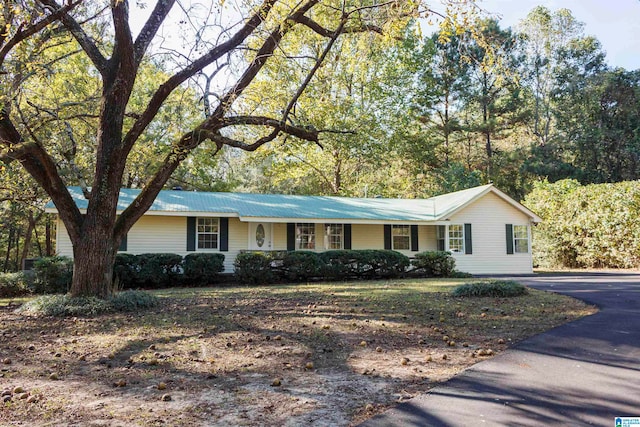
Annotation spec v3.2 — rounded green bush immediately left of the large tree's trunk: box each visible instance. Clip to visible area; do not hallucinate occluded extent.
[32,256,73,294]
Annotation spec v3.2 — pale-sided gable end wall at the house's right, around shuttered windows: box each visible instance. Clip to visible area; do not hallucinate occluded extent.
[449,193,533,274]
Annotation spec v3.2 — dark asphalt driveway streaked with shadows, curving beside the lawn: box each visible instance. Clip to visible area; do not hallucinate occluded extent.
[362,273,640,427]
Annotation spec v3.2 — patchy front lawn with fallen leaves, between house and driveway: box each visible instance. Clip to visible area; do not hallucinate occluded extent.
[0,279,595,426]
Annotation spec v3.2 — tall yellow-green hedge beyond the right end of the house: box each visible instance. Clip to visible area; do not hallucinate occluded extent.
[523,180,640,268]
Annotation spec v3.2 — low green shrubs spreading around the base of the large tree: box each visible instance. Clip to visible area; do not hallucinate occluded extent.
[16,291,158,317]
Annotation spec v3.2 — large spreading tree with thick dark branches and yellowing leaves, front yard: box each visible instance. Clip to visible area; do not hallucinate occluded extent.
[0,0,470,297]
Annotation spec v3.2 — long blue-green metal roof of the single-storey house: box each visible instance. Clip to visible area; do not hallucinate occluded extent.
[46,184,536,222]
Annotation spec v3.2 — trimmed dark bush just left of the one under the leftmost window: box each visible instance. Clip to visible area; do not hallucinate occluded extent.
[137,253,182,289]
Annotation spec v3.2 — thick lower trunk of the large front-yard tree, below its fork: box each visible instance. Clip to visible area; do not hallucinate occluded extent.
[71,227,116,298]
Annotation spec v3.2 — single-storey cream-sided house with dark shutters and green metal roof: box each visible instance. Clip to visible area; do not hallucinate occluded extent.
[46,184,541,274]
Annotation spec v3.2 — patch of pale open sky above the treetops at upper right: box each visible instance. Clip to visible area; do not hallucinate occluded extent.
[477,0,640,70]
